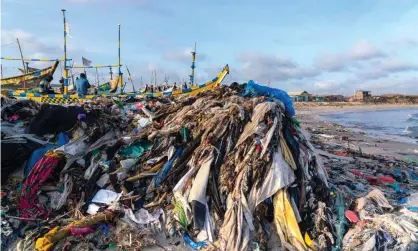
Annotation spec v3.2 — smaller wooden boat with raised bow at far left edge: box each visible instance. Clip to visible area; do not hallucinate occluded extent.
[0,61,59,90]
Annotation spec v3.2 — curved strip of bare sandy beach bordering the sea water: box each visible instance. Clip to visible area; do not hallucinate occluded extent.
[295,103,418,160]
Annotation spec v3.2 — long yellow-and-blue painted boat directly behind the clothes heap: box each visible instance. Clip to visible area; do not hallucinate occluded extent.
[2,65,229,104]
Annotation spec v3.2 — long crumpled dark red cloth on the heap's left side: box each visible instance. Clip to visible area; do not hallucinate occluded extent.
[19,152,61,218]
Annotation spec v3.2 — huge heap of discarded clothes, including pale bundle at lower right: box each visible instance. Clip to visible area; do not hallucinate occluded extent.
[1,81,417,250]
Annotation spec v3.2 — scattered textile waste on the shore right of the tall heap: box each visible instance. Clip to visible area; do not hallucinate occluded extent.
[306,118,418,250]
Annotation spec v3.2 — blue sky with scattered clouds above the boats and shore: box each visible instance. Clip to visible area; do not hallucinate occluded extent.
[1,0,418,95]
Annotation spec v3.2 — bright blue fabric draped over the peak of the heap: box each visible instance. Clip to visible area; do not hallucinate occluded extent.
[242,80,295,117]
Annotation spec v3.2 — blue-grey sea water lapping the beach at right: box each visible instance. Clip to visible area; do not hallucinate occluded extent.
[321,109,418,143]
